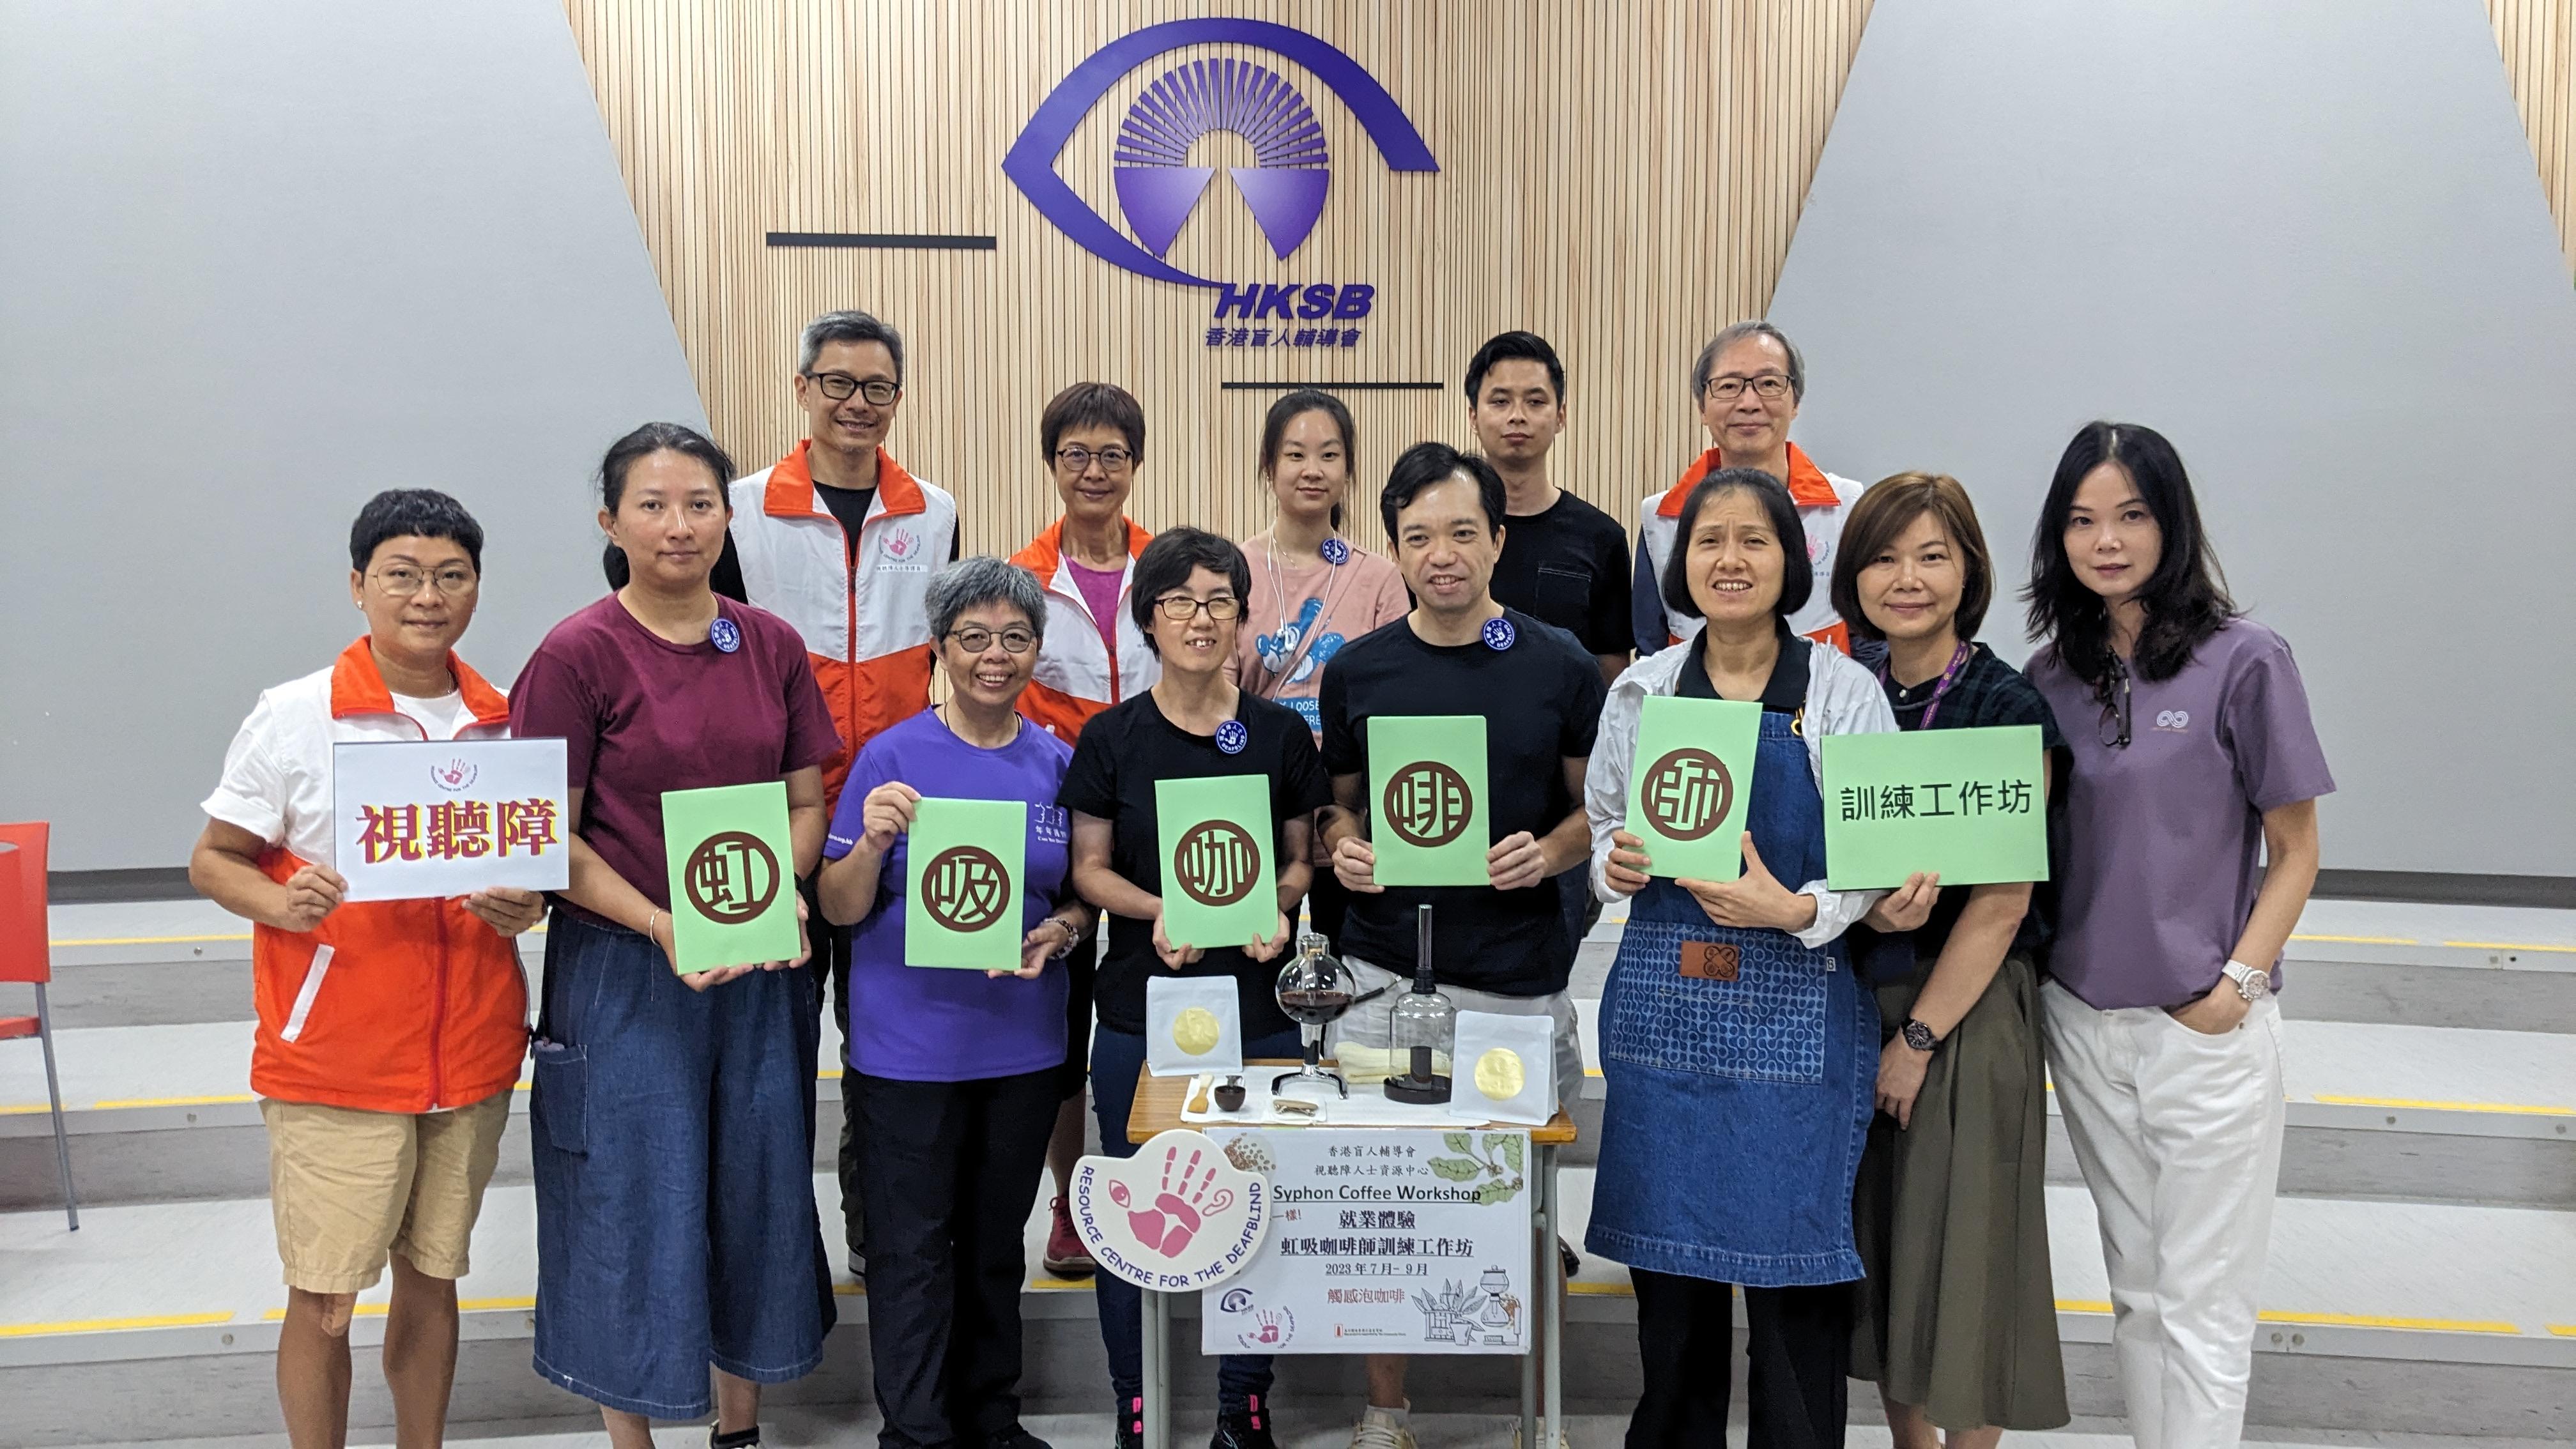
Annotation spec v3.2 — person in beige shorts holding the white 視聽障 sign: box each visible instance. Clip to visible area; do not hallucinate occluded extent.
[188,487,543,1444]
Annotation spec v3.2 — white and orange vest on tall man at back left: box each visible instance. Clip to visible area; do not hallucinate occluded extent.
[734,438,958,804]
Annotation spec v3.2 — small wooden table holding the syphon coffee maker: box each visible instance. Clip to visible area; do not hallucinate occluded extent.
[1128,1057,1574,1449]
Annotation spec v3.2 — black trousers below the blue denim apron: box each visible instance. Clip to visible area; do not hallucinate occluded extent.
[1628,1269,1852,1449]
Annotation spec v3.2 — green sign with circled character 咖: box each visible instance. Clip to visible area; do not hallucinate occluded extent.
[1154,776,1280,951]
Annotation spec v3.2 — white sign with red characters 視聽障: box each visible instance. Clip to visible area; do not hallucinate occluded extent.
[330,740,572,900]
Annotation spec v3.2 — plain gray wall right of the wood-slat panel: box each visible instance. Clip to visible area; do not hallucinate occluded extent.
[1772,0,2576,877]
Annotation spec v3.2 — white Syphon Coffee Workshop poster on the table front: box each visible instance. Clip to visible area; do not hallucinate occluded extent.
[1198,1119,1553,1354]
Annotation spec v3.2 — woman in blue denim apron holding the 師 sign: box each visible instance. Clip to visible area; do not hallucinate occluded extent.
[1584,469,1896,1449]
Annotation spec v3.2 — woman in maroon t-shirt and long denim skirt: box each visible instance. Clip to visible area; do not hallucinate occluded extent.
[510,423,839,1449]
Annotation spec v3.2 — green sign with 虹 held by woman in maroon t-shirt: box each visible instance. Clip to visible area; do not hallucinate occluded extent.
[662,779,801,974]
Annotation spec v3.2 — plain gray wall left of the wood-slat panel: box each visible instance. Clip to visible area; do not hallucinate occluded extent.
[0,0,703,871]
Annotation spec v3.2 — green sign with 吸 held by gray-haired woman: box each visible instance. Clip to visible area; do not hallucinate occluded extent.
[904,799,1028,972]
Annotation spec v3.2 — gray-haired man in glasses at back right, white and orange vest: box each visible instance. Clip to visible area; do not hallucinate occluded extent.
[1628,319,1862,655]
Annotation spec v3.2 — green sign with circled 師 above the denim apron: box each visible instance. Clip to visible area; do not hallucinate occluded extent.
[1628,694,1761,884]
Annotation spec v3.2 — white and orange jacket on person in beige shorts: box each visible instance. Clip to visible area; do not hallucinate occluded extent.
[206,640,528,1114]
